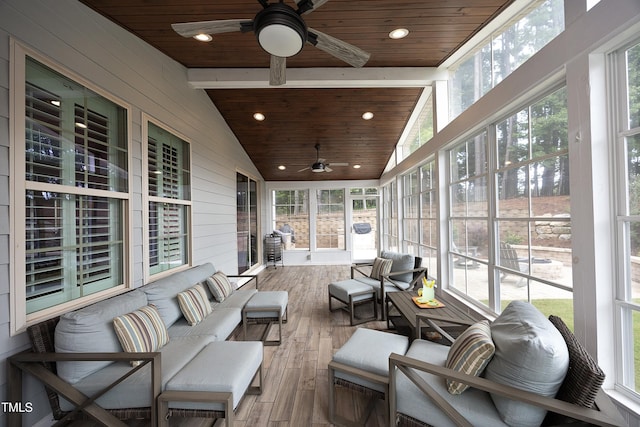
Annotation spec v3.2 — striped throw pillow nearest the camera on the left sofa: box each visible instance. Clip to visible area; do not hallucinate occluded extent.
[113,305,169,366]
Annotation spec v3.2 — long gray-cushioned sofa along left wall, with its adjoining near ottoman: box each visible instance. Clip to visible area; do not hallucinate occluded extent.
[8,263,263,425]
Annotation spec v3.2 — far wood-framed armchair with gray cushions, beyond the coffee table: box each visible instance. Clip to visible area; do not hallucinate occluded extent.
[351,251,427,320]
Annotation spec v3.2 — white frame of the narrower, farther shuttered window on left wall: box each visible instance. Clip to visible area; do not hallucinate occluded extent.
[142,113,193,283]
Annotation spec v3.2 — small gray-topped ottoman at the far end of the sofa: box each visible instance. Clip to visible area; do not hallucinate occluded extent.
[242,291,289,345]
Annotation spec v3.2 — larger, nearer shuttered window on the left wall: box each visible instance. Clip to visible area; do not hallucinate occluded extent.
[12,49,129,330]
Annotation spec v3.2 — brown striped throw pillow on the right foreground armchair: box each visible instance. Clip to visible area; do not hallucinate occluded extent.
[445,320,496,394]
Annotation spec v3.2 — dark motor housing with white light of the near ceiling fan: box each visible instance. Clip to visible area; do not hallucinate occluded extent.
[253,3,307,58]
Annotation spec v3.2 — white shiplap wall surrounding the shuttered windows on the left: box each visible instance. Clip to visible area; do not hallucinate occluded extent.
[0,0,260,426]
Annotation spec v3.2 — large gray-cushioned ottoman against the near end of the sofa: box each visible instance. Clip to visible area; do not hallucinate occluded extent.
[158,341,263,427]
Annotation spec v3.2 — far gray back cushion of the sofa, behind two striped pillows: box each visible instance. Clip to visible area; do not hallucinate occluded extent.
[141,263,216,328]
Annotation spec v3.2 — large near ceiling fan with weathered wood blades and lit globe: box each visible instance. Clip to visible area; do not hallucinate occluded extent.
[171,0,370,86]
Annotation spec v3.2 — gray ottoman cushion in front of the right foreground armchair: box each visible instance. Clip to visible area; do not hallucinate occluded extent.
[333,328,409,392]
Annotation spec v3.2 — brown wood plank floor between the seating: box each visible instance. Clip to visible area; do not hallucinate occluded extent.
[74,265,388,427]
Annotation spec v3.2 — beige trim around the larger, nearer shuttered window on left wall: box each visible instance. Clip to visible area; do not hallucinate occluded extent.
[9,38,133,336]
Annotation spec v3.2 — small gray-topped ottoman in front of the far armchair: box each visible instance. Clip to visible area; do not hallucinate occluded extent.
[329,279,378,326]
